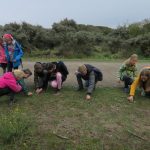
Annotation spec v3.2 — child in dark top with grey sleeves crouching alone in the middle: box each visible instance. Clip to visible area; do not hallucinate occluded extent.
[75,64,103,100]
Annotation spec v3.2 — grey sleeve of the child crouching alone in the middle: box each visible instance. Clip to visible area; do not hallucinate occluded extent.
[87,71,95,94]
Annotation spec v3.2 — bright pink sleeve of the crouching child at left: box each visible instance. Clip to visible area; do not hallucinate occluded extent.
[7,79,22,93]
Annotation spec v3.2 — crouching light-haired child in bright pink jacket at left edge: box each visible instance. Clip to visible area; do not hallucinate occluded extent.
[0,70,25,105]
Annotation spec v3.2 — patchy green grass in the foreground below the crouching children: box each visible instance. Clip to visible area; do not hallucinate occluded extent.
[0,87,150,150]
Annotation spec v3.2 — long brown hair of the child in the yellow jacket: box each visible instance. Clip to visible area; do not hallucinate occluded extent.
[139,69,150,89]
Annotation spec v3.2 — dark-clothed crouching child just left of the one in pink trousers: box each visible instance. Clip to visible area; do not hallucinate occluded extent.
[34,62,48,94]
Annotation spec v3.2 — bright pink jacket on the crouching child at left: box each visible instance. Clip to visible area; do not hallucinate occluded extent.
[0,72,22,93]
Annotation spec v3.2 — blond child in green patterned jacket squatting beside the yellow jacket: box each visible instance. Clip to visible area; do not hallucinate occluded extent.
[119,54,138,93]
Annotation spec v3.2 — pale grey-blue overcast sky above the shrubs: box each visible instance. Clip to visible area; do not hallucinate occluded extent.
[0,0,150,28]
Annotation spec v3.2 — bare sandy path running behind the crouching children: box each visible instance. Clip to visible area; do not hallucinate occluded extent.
[0,61,149,87]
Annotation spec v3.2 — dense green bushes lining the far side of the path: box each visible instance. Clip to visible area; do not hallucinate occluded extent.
[0,19,150,57]
